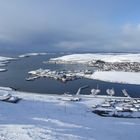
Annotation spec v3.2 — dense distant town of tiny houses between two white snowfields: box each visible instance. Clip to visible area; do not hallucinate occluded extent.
[88,60,140,72]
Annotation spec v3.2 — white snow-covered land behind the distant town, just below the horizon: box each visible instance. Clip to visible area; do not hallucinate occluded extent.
[50,53,140,63]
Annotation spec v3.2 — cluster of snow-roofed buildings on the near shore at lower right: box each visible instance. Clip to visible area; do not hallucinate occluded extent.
[92,97,140,118]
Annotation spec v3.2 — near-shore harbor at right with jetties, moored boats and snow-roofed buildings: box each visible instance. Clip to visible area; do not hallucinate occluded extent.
[62,85,140,118]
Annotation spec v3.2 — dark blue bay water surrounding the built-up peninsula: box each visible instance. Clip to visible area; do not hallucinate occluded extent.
[0,54,140,97]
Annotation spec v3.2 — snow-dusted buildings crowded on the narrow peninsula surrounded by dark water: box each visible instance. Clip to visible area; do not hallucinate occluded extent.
[26,69,92,82]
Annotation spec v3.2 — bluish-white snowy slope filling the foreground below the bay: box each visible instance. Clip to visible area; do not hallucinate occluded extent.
[0,88,140,140]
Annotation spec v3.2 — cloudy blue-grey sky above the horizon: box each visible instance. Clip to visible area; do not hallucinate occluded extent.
[0,0,140,52]
